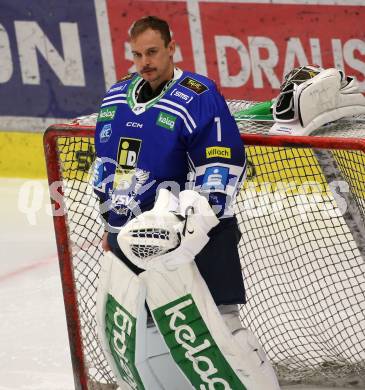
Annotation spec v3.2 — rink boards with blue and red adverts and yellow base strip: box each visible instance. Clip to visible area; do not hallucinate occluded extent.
[0,0,365,177]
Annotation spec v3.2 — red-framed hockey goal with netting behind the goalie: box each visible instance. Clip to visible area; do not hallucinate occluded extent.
[44,108,365,389]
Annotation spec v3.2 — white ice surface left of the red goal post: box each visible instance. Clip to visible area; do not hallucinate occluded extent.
[0,179,74,390]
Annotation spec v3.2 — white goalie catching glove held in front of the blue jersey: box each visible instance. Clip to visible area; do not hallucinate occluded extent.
[117,189,219,269]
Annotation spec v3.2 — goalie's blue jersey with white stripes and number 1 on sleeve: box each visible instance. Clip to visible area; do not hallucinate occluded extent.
[93,69,245,229]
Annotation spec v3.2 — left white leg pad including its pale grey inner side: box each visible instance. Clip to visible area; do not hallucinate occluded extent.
[96,252,190,390]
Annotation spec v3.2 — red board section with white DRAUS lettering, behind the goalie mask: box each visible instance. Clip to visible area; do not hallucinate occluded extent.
[200,3,365,100]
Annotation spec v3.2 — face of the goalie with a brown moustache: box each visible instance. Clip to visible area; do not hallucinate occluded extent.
[131,29,175,88]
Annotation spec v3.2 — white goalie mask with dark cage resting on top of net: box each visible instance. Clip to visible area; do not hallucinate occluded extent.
[270,66,365,135]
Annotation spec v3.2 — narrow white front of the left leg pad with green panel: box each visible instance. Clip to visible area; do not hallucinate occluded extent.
[96,252,162,389]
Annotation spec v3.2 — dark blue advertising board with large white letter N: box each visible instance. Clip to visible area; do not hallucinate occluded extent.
[0,0,105,122]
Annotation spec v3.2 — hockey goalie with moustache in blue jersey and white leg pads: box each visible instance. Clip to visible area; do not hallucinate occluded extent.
[93,16,278,390]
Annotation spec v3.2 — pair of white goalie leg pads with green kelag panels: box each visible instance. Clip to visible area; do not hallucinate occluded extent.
[97,253,280,390]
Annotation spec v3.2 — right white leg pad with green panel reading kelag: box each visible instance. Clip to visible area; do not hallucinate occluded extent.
[140,262,253,390]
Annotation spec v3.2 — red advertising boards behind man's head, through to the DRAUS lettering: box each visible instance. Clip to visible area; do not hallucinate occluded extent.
[108,0,365,100]
